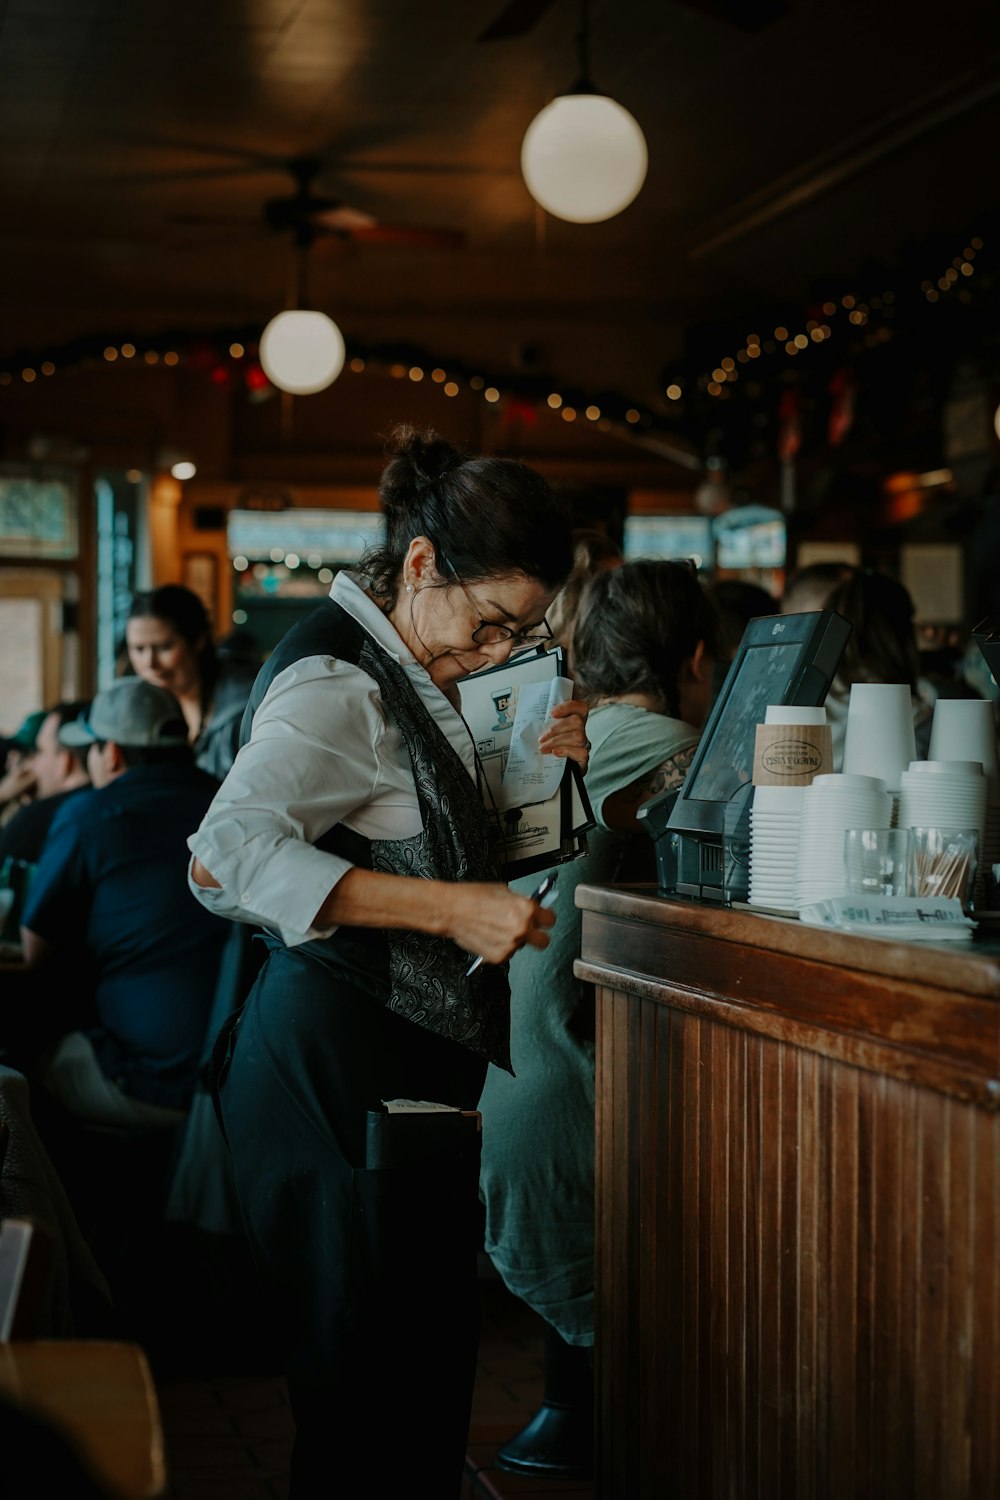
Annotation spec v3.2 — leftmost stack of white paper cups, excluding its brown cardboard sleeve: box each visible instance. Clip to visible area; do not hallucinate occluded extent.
[747,704,832,912]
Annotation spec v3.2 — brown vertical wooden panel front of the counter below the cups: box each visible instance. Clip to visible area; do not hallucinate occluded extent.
[597,987,1000,1500]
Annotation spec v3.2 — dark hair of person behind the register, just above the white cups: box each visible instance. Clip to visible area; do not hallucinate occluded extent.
[826,569,921,693]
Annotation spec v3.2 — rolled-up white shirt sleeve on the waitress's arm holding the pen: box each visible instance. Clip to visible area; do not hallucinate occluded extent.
[187,657,407,947]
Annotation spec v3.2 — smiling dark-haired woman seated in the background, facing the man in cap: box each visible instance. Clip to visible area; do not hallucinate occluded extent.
[124,584,256,780]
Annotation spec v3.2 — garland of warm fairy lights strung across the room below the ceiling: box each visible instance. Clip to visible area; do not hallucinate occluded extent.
[0,234,994,450]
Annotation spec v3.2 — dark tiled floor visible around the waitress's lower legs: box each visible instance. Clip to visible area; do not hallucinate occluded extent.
[157,1263,594,1500]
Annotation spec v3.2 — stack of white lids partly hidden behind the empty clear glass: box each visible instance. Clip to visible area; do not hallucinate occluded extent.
[795,771,892,909]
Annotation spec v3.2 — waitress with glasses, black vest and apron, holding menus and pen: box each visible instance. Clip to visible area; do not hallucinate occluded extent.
[189,428,588,1500]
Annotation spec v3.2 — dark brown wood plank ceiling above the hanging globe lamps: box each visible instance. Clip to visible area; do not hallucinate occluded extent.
[0,0,1000,401]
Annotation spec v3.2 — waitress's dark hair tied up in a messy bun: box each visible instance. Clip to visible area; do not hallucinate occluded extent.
[361,426,573,599]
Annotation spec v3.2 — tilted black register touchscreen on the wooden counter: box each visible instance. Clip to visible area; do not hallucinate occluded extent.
[667,609,850,842]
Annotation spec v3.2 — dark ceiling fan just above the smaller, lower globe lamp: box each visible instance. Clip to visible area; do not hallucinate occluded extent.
[174,156,465,249]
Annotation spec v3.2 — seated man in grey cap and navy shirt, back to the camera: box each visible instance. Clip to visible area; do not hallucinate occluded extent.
[21,677,228,1340]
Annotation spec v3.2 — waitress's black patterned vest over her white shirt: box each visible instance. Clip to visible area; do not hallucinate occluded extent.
[240,600,513,1073]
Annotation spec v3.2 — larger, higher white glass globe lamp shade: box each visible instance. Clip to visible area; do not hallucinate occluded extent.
[520,93,649,224]
